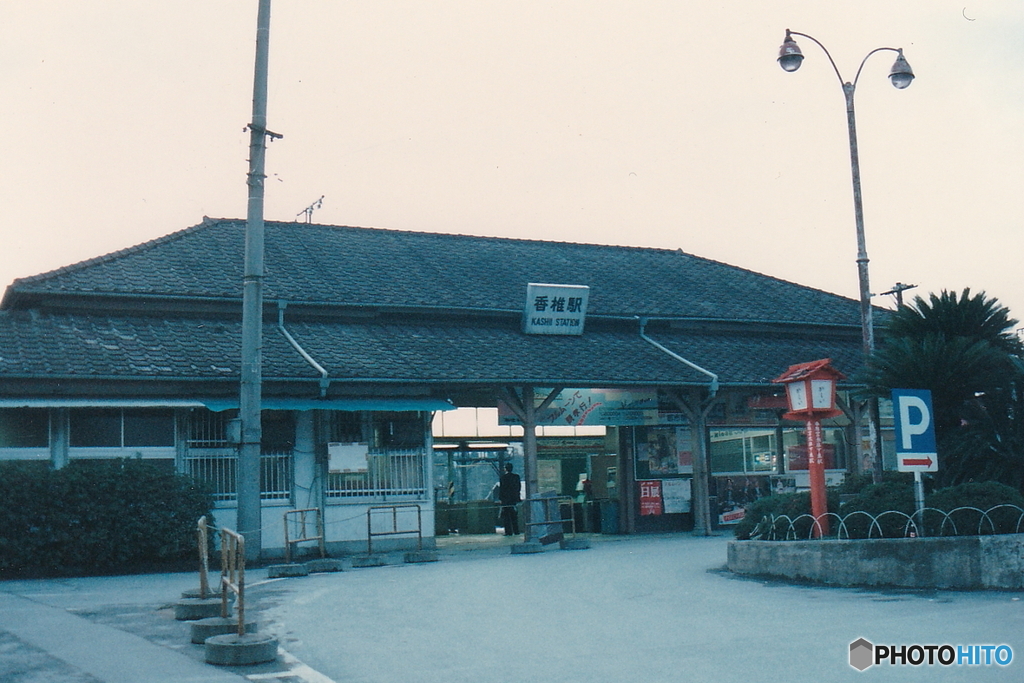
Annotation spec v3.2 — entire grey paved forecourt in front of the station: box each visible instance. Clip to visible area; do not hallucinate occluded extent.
[0,535,1024,683]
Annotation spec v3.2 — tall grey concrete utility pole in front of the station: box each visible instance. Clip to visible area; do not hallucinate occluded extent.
[238,0,270,561]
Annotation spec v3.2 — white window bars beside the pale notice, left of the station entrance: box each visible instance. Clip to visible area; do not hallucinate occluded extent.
[327,449,427,500]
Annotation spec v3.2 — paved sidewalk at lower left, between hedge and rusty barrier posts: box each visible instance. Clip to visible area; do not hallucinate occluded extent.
[0,569,326,683]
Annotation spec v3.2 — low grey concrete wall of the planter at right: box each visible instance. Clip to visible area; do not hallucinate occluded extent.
[728,533,1024,590]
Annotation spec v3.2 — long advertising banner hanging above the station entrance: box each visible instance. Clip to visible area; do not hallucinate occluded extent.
[498,389,657,427]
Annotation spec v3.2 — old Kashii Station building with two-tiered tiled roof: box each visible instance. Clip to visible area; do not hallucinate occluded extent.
[0,218,880,556]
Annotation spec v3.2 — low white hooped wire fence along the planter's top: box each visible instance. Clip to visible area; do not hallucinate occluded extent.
[751,504,1024,541]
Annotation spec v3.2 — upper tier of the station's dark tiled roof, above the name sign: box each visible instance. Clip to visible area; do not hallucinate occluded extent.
[6,219,859,326]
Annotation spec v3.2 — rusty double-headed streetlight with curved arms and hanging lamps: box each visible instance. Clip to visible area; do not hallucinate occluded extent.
[778,29,913,481]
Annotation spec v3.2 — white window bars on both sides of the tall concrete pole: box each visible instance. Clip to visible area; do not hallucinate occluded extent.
[184,447,292,503]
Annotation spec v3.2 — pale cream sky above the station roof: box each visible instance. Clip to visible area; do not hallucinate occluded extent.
[0,0,1024,327]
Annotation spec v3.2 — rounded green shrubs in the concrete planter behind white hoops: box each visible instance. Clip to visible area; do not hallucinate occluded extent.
[734,473,1024,539]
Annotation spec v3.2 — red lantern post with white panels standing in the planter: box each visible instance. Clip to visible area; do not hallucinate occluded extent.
[772,358,846,538]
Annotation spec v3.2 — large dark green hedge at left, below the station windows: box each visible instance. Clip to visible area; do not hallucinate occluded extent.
[0,460,213,578]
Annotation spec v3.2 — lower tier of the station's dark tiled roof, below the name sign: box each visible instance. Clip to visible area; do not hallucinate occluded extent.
[0,311,859,392]
